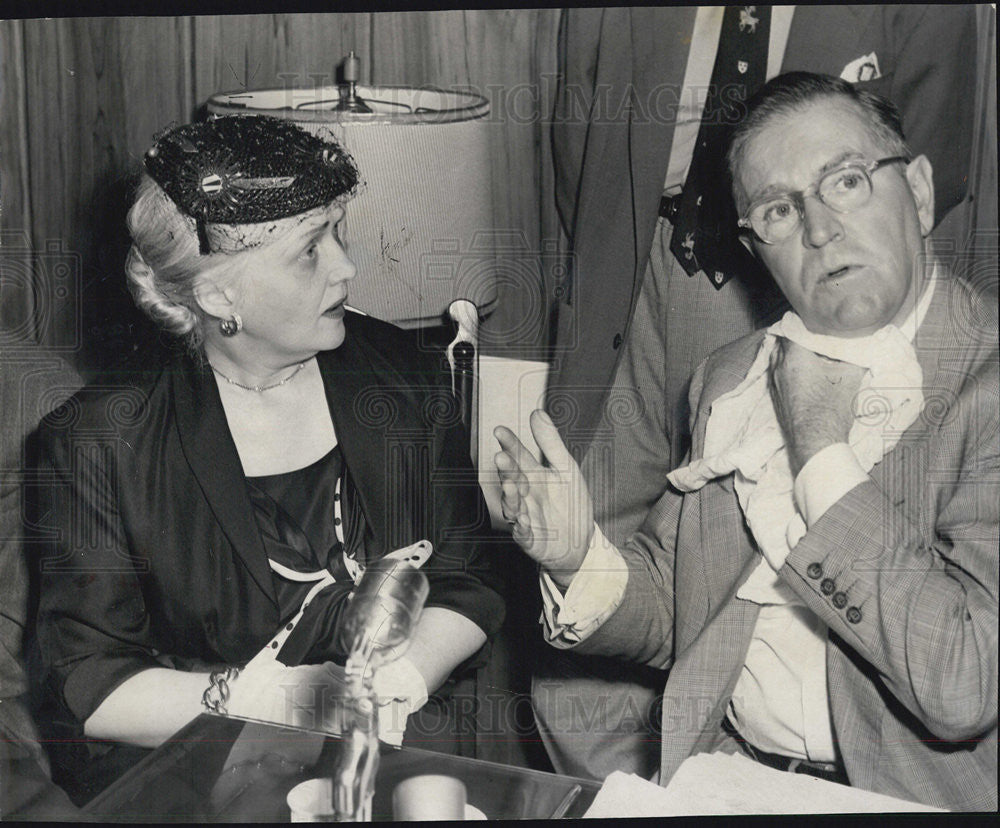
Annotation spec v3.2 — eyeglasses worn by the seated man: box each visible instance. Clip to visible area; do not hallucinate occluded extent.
[737,155,910,244]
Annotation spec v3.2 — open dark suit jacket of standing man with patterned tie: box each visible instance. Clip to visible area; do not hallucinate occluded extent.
[550,5,976,452]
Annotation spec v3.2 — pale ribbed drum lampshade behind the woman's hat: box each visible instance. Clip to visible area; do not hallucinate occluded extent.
[208,86,497,327]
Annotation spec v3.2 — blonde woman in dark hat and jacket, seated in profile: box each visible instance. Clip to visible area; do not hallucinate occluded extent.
[39,116,503,788]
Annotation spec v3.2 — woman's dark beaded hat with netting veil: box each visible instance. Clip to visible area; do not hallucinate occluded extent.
[145,115,359,254]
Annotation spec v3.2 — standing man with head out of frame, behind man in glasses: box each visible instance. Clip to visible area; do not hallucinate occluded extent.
[533,8,977,778]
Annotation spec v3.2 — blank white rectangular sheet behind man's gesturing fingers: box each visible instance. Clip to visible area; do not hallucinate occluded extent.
[478,355,549,528]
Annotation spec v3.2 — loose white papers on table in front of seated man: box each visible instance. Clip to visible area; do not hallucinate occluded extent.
[585,753,941,818]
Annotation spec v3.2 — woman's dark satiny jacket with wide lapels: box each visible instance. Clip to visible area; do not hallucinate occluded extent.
[33,314,503,726]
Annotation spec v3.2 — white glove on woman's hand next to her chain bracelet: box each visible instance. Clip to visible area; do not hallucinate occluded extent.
[226,658,345,732]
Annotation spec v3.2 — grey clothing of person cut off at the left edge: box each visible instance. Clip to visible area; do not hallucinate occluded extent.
[0,341,80,820]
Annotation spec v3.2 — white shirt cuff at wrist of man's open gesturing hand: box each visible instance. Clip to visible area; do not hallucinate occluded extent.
[539,524,628,649]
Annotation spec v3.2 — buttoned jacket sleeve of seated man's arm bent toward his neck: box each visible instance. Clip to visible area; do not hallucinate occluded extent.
[780,352,1000,741]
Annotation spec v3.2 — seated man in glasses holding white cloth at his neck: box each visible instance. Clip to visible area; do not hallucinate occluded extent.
[496,73,1000,810]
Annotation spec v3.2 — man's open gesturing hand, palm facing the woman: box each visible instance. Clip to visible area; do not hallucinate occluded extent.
[493,409,594,589]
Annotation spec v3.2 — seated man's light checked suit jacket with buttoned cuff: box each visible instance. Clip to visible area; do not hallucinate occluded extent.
[577,280,1000,810]
